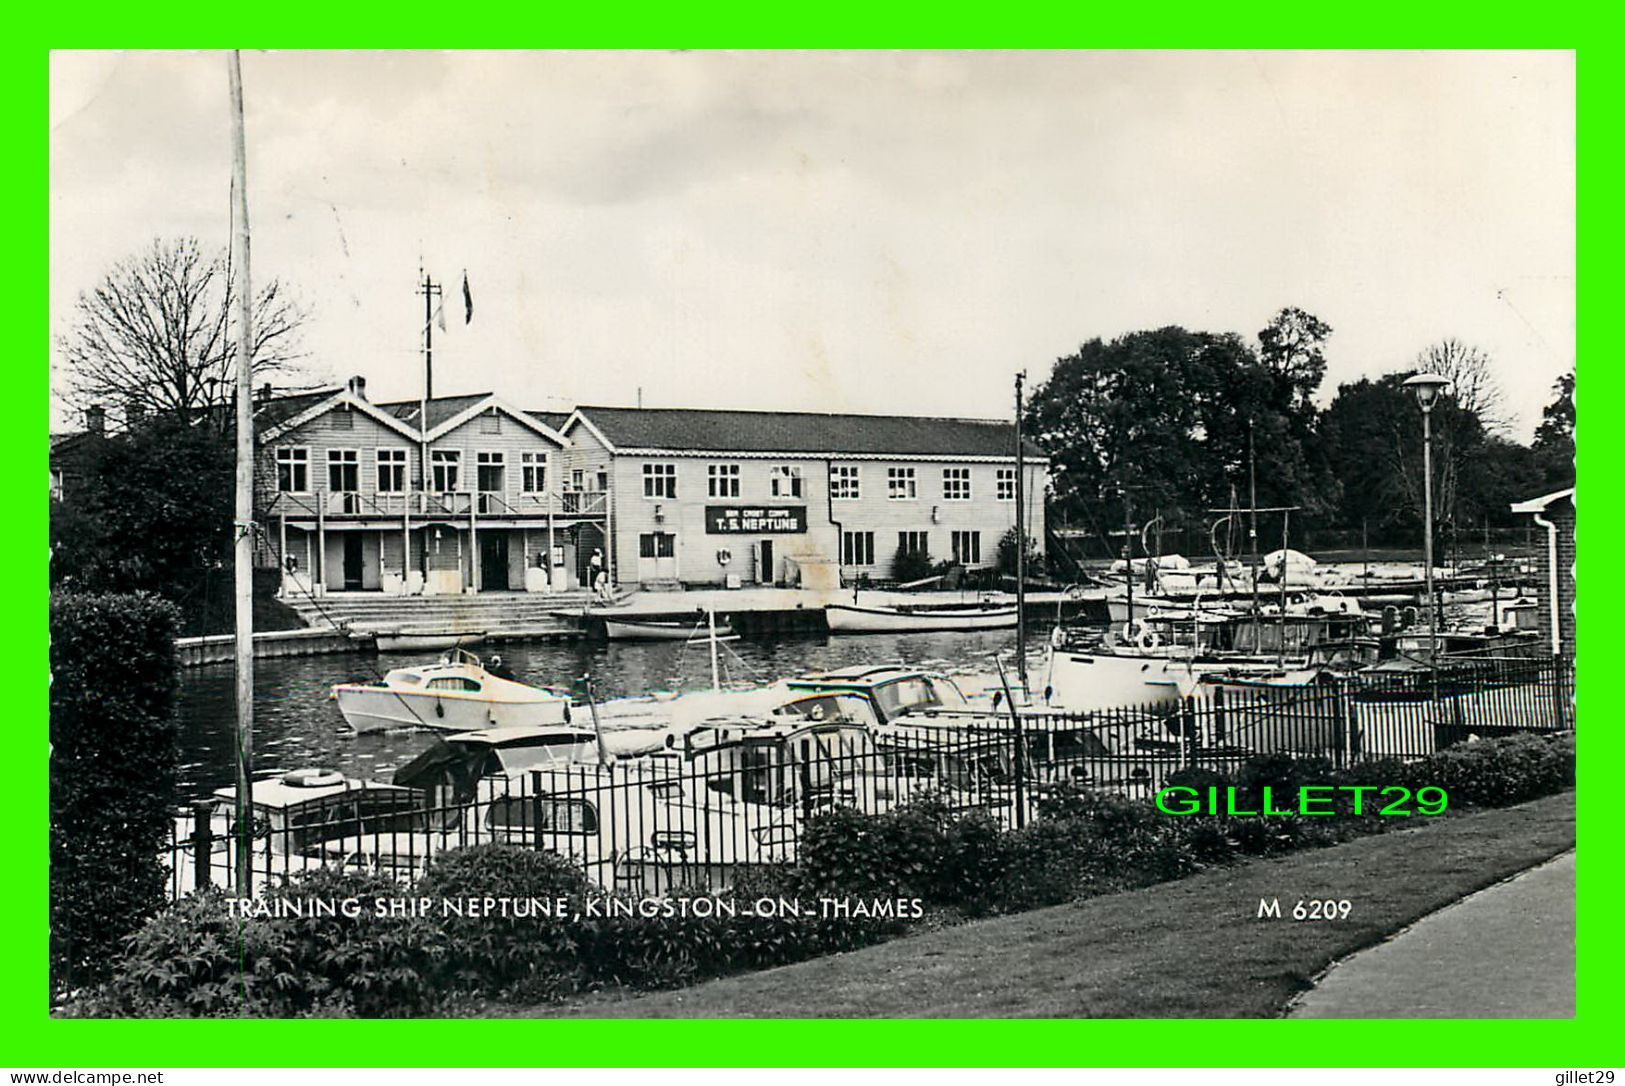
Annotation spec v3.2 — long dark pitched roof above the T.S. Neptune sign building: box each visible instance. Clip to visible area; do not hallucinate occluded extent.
[575,406,1047,458]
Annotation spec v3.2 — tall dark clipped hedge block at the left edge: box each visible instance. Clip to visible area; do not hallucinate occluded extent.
[50,593,179,990]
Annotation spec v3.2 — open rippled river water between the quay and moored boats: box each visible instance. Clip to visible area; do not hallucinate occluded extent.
[177,631,1016,800]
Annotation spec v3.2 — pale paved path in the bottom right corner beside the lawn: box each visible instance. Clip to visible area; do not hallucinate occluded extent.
[1289,852,1575,1018]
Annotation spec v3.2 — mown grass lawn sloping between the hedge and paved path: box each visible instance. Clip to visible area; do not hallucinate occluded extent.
[533,792,1575,1018]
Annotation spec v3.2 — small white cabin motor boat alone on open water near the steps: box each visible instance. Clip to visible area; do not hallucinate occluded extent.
[333,652,570,732]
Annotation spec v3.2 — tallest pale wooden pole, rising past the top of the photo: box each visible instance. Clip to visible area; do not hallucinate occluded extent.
[228,49,254,897]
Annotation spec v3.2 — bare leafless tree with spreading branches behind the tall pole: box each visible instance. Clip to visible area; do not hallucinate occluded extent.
[57,237,306,419]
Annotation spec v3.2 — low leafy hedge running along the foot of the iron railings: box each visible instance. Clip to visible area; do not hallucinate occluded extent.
[67,735,1575,1016]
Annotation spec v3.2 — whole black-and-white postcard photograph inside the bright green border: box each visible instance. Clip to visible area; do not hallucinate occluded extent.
[49,49,1576,1020]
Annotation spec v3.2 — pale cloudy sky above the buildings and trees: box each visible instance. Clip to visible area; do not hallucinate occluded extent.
[50,52,1575,439]
